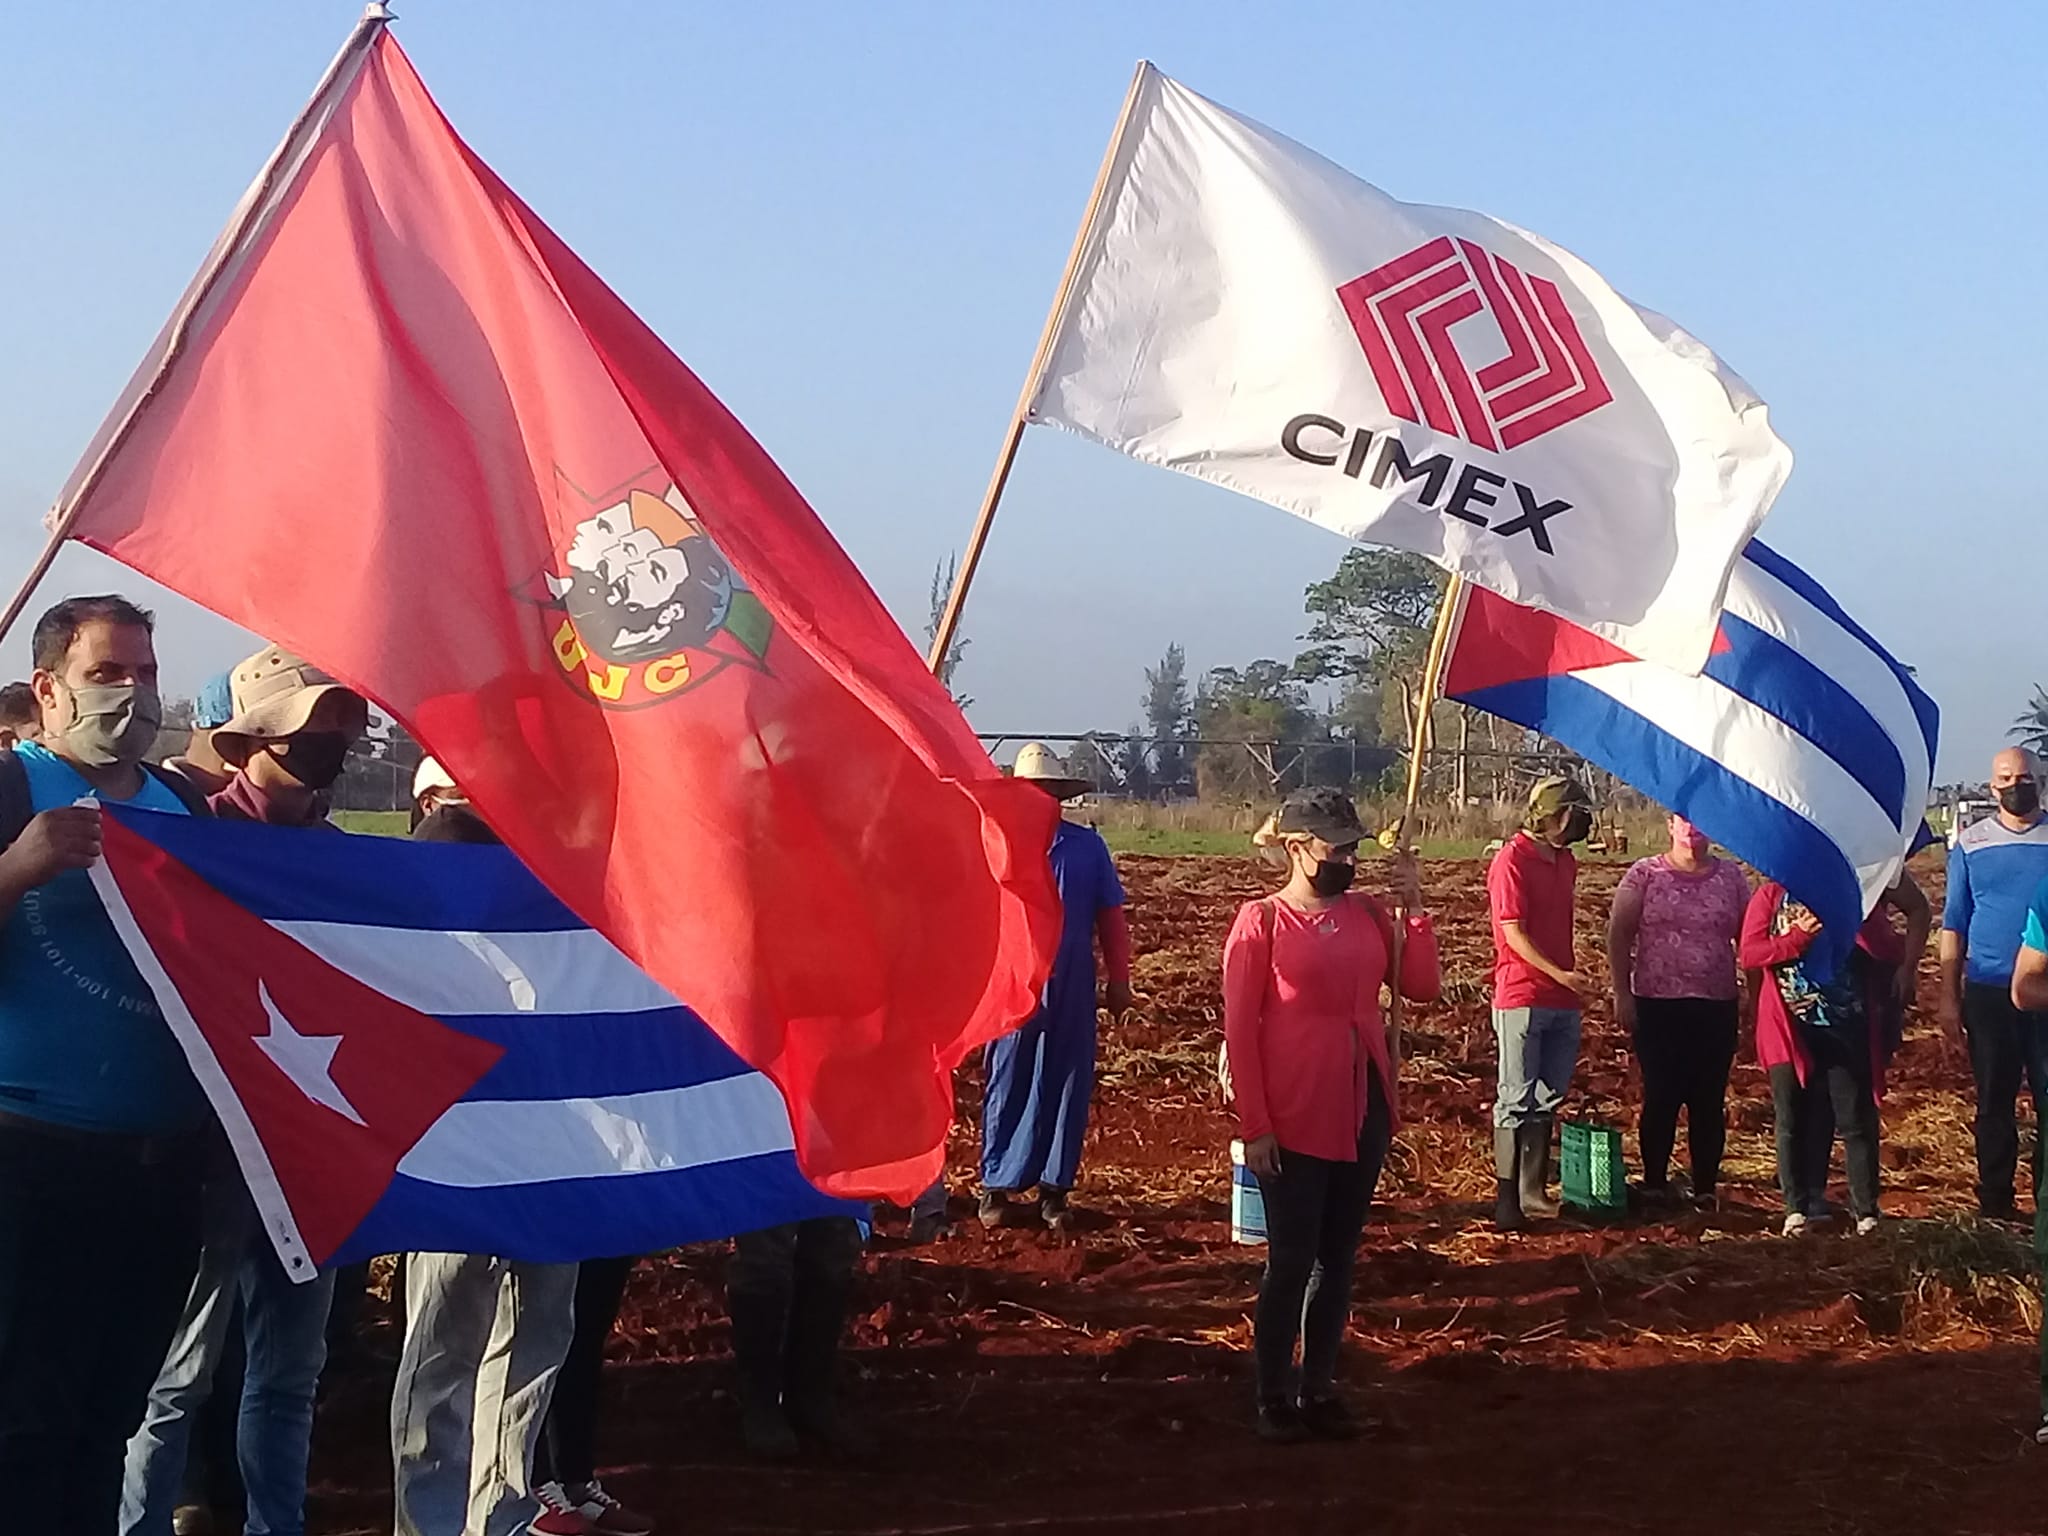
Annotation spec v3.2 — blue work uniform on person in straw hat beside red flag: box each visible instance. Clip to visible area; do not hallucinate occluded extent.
[981,819,1124,1190]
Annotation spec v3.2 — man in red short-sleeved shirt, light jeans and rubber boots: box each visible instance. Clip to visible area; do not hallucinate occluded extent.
[1487,778,1593,1231]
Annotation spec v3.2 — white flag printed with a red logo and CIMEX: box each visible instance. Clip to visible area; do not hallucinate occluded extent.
[1030,66,1792,672]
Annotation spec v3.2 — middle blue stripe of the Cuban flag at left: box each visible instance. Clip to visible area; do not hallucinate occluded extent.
[442,1008,752,1100]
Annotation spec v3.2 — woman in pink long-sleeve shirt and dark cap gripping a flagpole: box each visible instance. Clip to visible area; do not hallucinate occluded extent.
[1223,788,1442,1442]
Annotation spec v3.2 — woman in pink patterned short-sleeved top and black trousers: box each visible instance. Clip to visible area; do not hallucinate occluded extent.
[1608,815,1749,1210]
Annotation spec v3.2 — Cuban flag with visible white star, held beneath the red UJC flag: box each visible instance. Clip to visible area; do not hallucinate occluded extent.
[92,805,864,1280]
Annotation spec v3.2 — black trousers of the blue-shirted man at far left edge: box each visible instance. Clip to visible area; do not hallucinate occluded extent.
[0,1124,201,1536]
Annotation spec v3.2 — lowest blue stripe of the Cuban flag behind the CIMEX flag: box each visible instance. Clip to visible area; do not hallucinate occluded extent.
[1458,674,1864,975]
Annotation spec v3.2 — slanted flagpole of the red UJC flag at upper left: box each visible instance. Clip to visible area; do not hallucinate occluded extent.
[0,0,393,639]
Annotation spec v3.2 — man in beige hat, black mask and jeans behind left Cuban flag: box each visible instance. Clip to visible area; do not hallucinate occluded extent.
[121,645,369,1536]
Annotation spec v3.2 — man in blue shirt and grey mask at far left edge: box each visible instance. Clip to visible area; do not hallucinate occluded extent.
[0,596,207,1536]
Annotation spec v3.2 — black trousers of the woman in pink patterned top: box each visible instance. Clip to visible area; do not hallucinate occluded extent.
[1634,997,1737,1194]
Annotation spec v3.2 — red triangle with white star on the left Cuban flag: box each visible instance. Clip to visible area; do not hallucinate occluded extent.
[100,815,504,1264]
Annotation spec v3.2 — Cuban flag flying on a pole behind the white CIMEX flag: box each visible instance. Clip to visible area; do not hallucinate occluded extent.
[1444,541,1939,963]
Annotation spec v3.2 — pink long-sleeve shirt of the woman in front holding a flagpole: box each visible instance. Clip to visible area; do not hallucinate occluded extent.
[1223,893,1442,1163]
